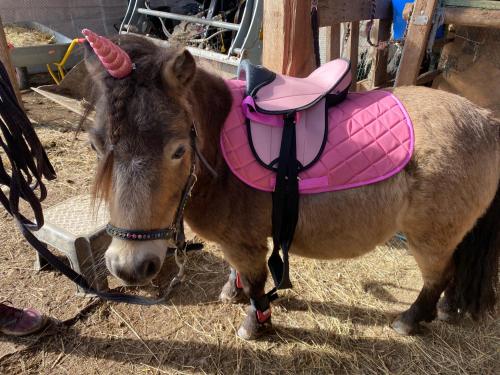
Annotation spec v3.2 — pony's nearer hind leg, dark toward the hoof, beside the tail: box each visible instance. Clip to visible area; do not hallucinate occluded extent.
[392,240,454,335]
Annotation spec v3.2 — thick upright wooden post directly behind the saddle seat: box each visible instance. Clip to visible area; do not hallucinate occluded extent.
[262,0,315,77]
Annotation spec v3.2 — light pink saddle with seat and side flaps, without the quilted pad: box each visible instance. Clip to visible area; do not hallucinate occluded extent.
[238,59,351,171]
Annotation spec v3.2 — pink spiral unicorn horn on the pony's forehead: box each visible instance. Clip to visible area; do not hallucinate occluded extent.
[82,29,133,78]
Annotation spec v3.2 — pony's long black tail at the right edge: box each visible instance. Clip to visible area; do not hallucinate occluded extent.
[453,186,500,319]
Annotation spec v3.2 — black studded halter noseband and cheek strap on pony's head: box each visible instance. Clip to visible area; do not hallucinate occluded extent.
[106,122,199,251]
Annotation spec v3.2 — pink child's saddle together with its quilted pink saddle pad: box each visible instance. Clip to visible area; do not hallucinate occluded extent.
[221,76,414,194]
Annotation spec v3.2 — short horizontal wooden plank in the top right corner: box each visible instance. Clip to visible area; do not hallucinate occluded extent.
[444,7,500,29]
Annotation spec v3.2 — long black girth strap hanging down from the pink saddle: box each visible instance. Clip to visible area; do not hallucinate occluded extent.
[268,112,299,300]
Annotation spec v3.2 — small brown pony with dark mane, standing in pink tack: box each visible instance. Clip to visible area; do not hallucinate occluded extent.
[87,36,500,338]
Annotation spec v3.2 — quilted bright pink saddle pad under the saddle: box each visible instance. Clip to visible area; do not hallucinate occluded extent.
[221,80,414,194]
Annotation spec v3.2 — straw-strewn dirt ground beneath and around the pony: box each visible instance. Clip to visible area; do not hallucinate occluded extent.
[0,93,500,375]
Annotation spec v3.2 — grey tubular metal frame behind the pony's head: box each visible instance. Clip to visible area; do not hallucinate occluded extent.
[120,0,264,76]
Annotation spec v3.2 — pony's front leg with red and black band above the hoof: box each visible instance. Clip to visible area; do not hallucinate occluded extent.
[221,243,271,340]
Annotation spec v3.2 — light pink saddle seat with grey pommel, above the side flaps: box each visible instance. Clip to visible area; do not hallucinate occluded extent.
[238,59,351,115]
